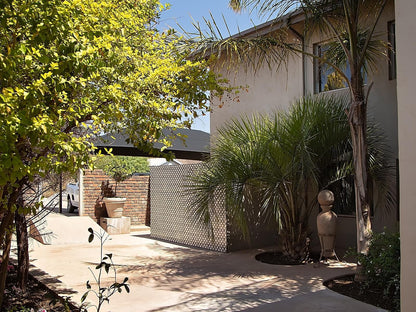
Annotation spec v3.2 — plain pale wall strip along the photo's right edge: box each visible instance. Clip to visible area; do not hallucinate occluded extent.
[396,0,416,312]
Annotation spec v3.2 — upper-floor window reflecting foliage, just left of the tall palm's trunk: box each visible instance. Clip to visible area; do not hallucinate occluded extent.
[314,44,350,93]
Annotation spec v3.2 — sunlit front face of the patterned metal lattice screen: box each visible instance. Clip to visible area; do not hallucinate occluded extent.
[150,164,227,252]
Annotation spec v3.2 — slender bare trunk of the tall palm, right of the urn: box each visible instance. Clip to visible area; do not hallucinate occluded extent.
[349,88,371,254]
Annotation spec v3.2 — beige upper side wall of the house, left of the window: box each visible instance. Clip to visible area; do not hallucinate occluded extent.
[210,31,303,137]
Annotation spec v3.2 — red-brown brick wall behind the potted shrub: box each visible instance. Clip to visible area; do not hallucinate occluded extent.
[83,169,150,226]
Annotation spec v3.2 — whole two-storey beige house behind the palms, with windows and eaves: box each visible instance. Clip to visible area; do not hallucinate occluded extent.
[210,0,399,250]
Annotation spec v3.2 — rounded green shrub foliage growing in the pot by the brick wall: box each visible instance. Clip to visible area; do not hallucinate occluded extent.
[94,156,149,197]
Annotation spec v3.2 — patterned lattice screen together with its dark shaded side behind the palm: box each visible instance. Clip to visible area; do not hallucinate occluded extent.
[150,164,276,252]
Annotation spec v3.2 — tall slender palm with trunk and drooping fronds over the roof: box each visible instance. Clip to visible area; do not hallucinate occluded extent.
[190,0,390,253]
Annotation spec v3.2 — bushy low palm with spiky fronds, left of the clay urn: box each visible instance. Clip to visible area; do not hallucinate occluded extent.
[189,97,377,260]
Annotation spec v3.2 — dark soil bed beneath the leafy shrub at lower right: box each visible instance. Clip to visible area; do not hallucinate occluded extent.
[324,275,395,311]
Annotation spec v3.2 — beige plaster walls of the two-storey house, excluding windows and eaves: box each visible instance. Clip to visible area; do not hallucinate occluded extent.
[211,0,398,255]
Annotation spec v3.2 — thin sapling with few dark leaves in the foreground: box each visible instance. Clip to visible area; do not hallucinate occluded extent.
[81,228,130,312]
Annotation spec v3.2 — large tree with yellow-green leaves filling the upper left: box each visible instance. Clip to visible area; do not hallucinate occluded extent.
[0,0,226,306]
